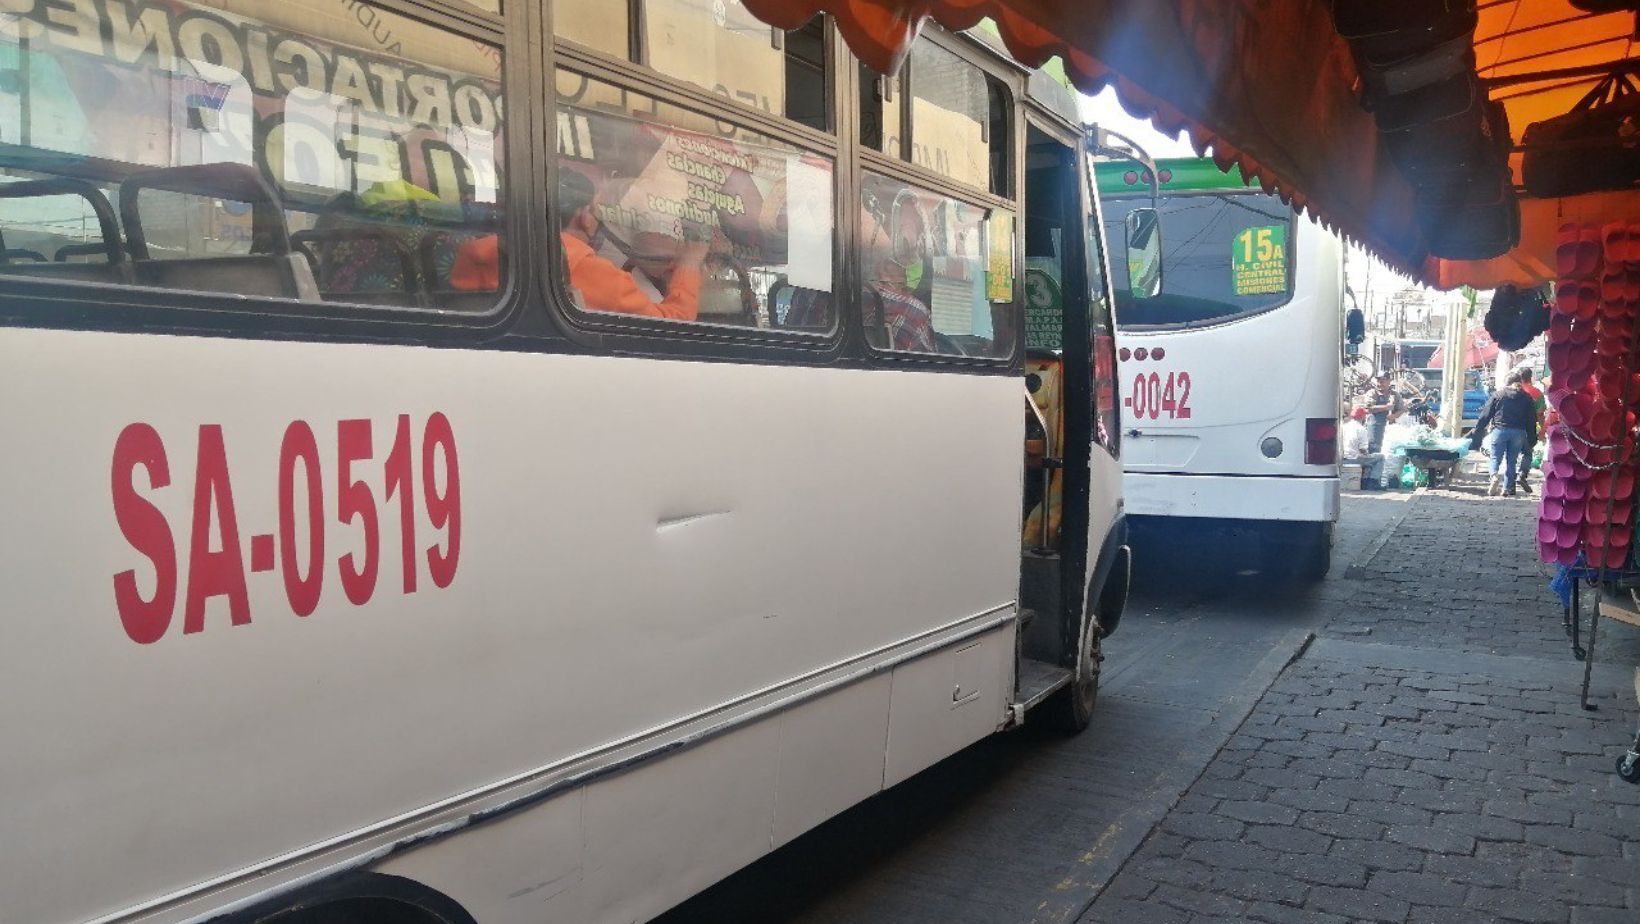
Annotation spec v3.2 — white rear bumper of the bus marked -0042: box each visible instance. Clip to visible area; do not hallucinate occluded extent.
[1122,473,1338,522]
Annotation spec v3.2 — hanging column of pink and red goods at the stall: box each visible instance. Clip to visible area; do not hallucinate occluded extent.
[1538,225,1640,568]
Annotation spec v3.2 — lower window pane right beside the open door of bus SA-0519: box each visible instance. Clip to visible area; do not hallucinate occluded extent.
[859,172,1014,358]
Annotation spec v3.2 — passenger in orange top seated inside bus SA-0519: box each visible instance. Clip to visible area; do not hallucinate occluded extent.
[449,167,708,320]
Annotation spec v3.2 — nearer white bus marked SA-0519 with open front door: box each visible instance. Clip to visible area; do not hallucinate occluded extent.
[0,0,1128,924]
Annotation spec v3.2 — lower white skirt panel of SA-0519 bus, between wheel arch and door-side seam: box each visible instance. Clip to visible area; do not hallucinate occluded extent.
[377,669,898,924]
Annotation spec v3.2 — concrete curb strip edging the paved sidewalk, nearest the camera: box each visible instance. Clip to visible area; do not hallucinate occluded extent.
[1032,629,1315,924]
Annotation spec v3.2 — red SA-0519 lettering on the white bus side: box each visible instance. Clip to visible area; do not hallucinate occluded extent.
[110,412,461,645]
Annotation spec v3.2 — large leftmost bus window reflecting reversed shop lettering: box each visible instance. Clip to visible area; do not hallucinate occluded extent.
[0,0,502,310]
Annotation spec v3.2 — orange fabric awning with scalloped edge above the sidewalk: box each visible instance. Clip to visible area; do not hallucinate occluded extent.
[745,0,1640,289]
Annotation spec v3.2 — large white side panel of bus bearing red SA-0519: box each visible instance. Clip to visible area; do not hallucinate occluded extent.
[0,328,1022,924]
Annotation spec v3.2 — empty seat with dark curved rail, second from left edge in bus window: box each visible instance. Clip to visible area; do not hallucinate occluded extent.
[120,162,320,302]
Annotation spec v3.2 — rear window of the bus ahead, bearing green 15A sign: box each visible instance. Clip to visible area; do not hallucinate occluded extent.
[1104,190,1292,330]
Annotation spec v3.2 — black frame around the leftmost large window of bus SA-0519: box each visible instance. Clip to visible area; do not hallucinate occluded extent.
[0,0,538,346]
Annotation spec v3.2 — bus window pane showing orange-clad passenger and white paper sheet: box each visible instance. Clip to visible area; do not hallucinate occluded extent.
[556,71,833,333]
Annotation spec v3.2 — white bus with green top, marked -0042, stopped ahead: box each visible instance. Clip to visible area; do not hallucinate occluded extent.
[1096,158,1343,578]
